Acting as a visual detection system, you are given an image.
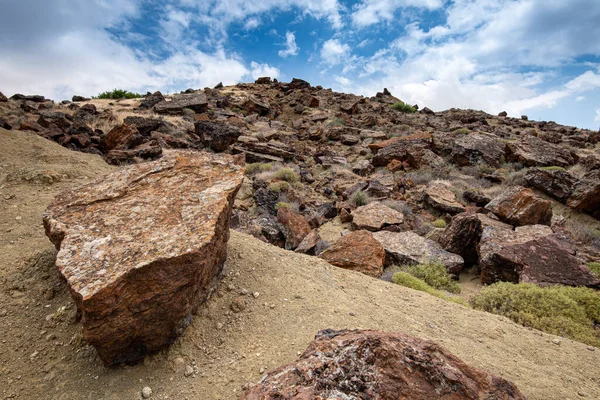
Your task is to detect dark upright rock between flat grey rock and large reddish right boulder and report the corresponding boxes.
[439,213,483,265]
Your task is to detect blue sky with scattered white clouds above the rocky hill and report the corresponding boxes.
[0,0,600,129]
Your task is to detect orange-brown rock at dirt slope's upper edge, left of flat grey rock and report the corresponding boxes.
[319,231,385,278]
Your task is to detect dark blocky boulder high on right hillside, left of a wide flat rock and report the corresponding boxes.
[450,133,505,168]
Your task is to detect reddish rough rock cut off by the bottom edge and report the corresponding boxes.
[241,330,525,400]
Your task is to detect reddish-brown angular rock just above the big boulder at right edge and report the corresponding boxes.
[485,186,552,226]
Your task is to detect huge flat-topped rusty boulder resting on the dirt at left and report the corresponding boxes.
[43,151,244,365]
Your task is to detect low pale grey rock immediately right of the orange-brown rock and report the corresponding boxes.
[373,231,464,274]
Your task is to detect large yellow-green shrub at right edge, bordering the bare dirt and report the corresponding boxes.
[471,282,600,347]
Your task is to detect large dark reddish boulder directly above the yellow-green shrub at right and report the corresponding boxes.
[480,225,600,287]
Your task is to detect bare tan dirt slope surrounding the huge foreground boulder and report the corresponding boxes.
[0,130,600,399]
